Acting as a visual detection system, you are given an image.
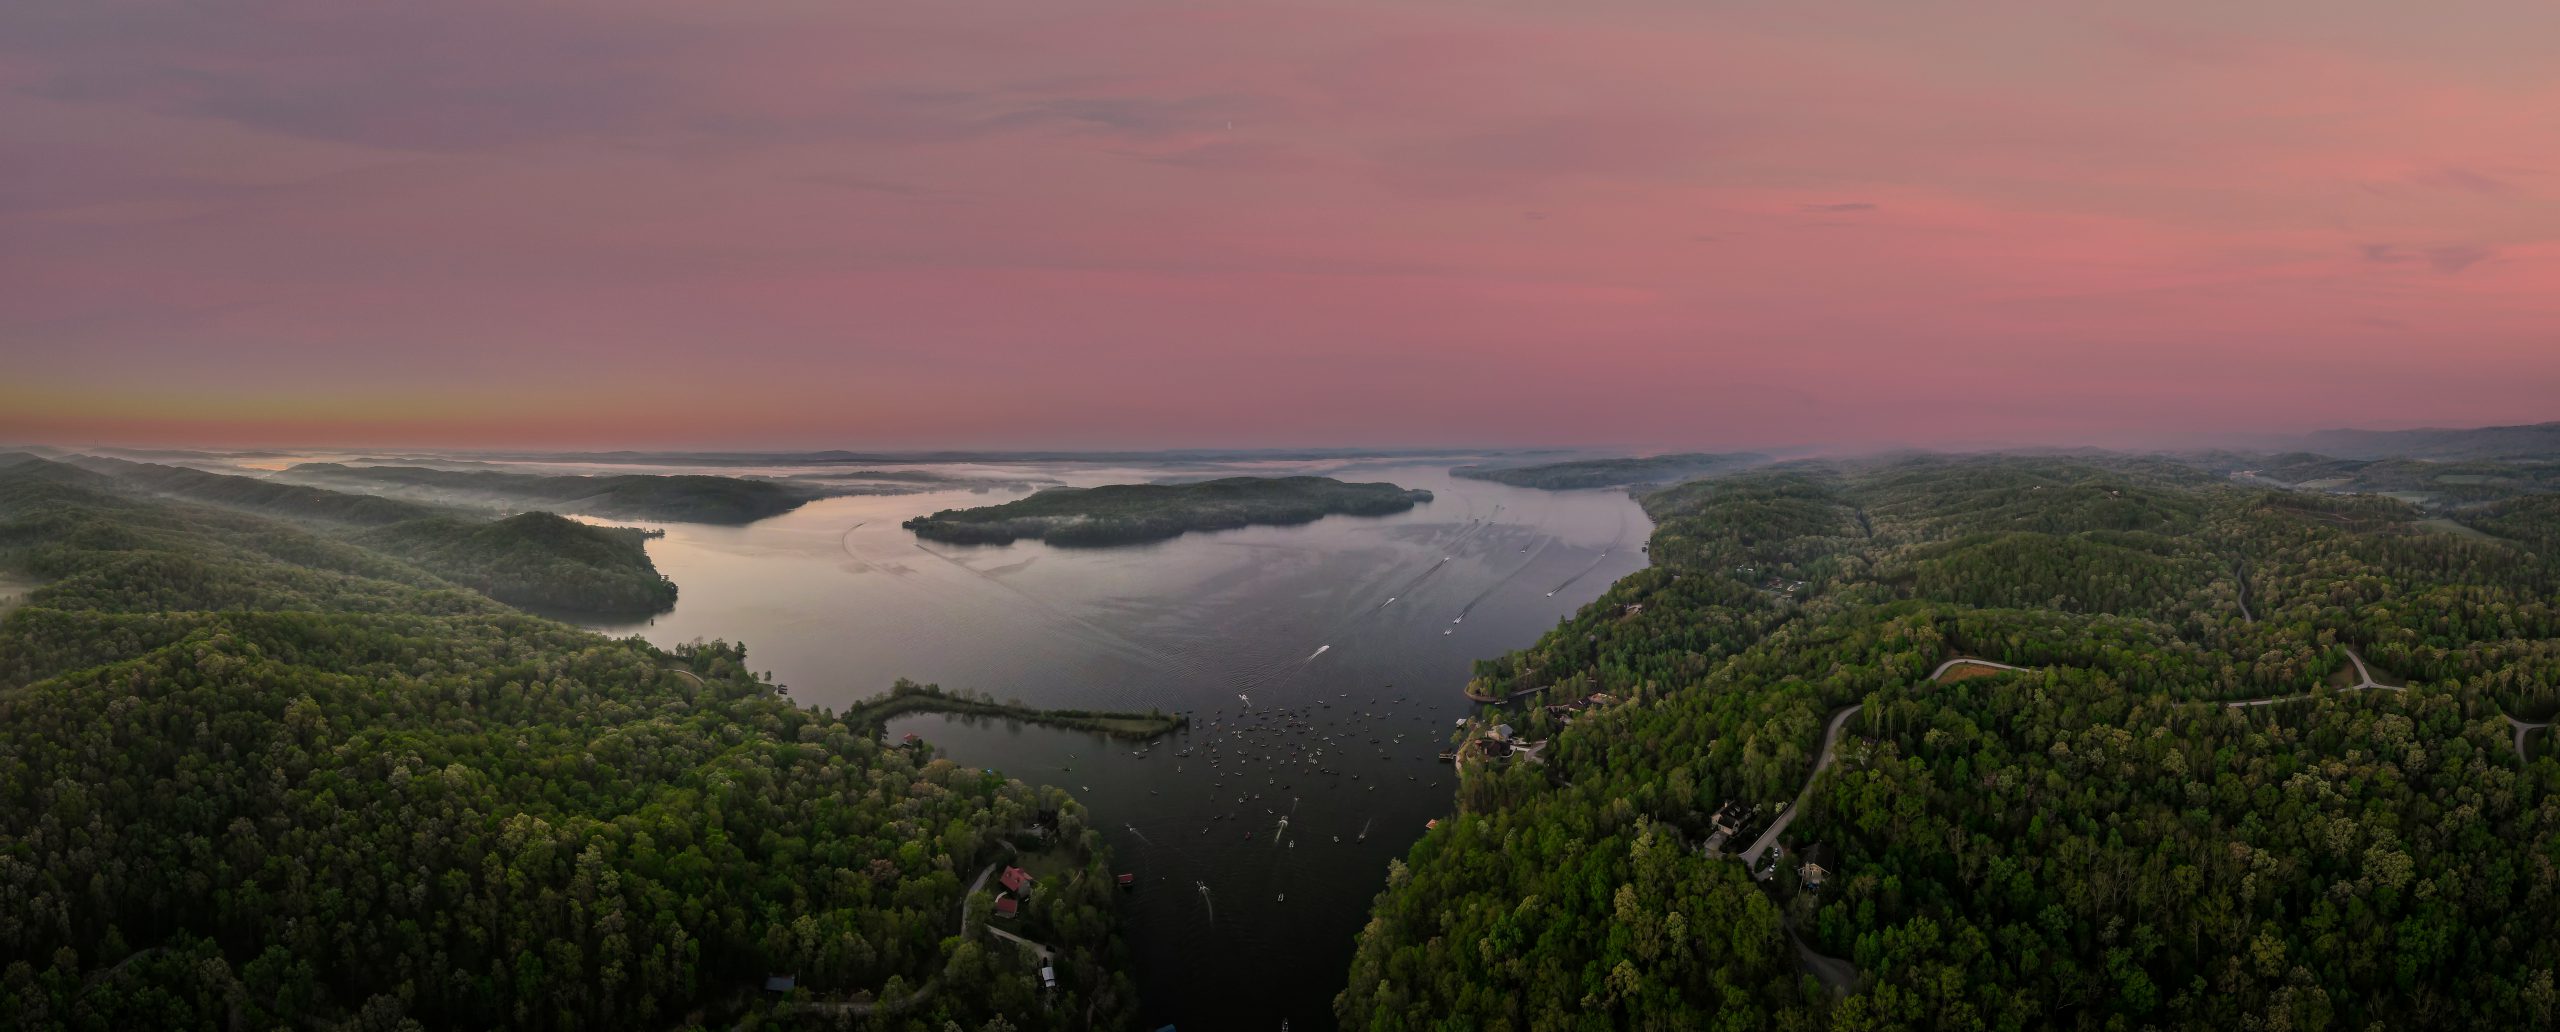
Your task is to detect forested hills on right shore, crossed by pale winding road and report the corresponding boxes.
[1336,458,2560,1032]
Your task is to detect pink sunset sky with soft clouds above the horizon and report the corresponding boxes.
[0,0,2560,448]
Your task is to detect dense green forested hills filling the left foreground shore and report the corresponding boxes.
[0,456,1134,1032]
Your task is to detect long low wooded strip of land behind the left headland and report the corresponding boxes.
[282,464,847,525]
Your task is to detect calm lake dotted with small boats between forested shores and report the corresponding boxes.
[583,464,1651,1029]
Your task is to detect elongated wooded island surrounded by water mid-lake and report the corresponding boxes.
[906,476,1431,545]
